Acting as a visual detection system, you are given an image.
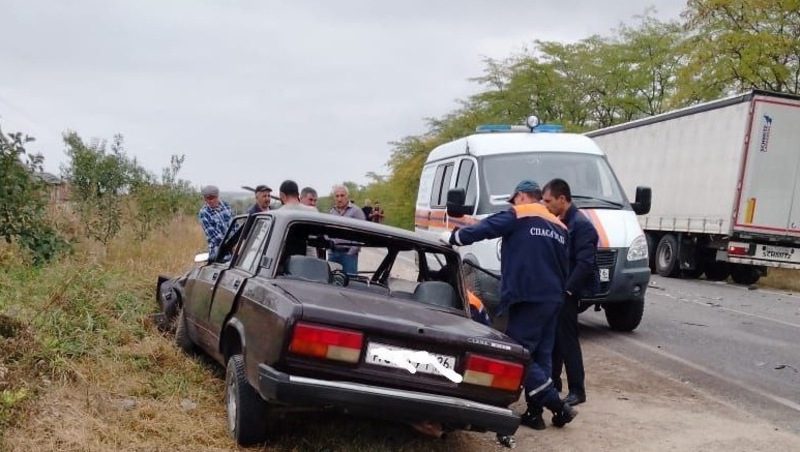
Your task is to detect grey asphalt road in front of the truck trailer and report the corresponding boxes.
[580,275,800,433]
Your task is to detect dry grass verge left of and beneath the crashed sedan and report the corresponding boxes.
[0,218,493,451]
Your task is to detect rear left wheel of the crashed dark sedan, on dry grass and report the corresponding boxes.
[225,354,267,446]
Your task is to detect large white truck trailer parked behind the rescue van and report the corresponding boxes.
[587,91,800,284]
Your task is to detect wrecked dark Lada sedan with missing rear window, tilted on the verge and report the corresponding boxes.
[157,209,529,444]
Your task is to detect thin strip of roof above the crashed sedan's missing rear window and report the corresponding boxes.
[255,207,452,250]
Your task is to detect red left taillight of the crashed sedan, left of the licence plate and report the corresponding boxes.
[289,322,364,363]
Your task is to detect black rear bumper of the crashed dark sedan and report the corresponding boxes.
[258,364,520,435]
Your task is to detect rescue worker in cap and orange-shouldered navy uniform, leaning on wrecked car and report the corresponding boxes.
[448,180,577,429]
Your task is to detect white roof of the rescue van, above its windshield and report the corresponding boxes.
[427,132,604,162]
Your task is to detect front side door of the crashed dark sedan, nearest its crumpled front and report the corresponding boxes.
[183,216,247,346]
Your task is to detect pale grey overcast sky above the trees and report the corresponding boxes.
[0,0,685,194]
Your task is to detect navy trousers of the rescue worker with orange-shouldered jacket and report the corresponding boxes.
[506,302,561,412]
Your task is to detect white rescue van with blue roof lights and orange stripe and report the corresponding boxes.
[415,117,650,331]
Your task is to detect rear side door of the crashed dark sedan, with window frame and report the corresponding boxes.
[208,216,272,343]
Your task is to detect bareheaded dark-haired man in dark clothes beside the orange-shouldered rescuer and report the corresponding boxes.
[543,179,598,405]
